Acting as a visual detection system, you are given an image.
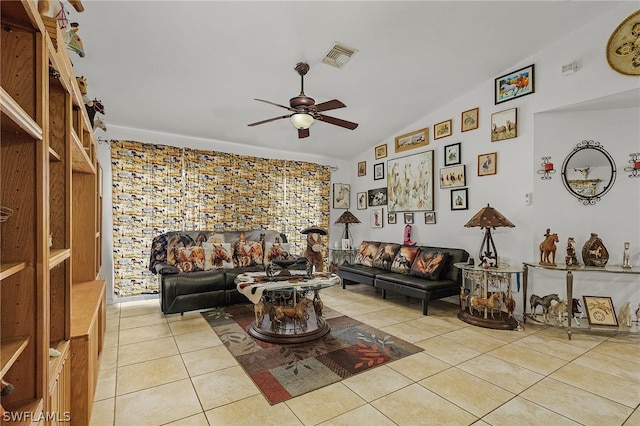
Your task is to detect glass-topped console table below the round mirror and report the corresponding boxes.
[522,262,640,340]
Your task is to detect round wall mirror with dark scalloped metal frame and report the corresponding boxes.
[562,141,616,205]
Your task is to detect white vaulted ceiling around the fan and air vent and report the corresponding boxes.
[68,0,616,159]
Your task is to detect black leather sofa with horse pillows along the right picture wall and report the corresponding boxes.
[338,241,469,315]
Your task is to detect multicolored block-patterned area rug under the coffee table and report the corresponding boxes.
[202,305,423,405]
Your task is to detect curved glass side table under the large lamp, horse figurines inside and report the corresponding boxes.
[454,262,522,330]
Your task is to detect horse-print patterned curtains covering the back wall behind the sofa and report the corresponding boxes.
[111,140,331,297]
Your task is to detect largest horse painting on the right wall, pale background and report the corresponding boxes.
[387,150,434,213]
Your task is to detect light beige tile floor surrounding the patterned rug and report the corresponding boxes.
[91,285,640,426]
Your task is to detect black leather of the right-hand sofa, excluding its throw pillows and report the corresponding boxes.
[338,243,469,315]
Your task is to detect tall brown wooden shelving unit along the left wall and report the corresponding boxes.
[0,0,105,424]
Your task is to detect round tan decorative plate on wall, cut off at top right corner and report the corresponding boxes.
[607,10,640,76]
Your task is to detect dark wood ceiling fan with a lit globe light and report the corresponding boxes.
[249,62,358,139]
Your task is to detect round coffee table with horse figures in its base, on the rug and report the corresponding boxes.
[235,271,340,343]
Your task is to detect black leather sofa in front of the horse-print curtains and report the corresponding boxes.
[149,229,306,314]
